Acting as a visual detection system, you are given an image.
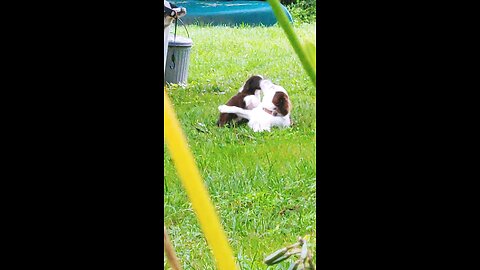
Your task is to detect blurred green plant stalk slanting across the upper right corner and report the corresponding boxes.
[267,0,317,86]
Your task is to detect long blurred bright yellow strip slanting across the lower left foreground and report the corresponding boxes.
[163,89,237,270]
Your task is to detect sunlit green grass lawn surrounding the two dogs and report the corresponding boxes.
[164,24,316,270]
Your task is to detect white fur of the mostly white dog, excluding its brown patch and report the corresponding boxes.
[218,80,291,132]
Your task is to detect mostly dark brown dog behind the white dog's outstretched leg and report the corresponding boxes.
[217,75,263,127]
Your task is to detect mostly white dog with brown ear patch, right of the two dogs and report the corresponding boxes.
[218,79,292,132]
